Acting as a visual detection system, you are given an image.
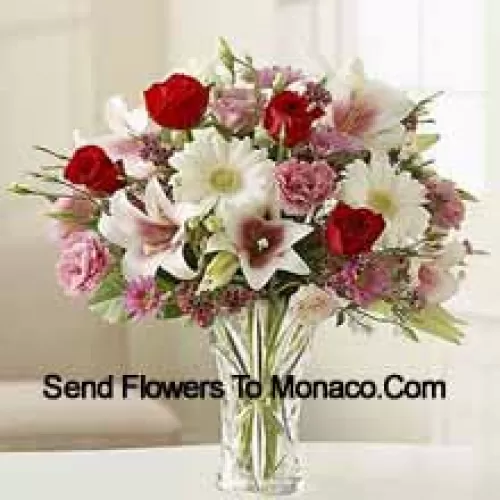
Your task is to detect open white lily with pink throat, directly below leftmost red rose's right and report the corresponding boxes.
[99,178,200,280]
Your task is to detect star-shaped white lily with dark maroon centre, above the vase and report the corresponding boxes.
[207,205,313,290]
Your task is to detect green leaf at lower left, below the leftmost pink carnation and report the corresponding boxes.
[89,269,128,323]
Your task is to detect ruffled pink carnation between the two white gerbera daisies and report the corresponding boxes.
[275,159,336,215]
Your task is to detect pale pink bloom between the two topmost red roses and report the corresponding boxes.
[212,88,260,134]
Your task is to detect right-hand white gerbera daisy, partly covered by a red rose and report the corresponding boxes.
[339,154,429,247]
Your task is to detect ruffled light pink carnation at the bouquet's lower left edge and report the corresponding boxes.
[56,231,111,295]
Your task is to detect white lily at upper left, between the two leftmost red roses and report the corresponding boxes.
[73,96,154,179]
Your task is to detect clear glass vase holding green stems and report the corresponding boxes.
[211,298,312,495]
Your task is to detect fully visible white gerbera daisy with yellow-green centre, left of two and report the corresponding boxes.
[170,130,274,215]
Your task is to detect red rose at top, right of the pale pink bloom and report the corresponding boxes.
[264,90,324,147]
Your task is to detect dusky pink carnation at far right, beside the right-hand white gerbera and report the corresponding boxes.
[426,177,465,229]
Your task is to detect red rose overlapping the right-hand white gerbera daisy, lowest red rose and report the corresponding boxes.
[326,202,385,255]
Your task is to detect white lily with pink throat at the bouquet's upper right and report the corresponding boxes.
[330,60,414,151]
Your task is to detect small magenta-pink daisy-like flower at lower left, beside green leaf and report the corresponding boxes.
[124,276,165,320]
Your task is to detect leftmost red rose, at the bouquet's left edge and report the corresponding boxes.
[64,146,125,194]
